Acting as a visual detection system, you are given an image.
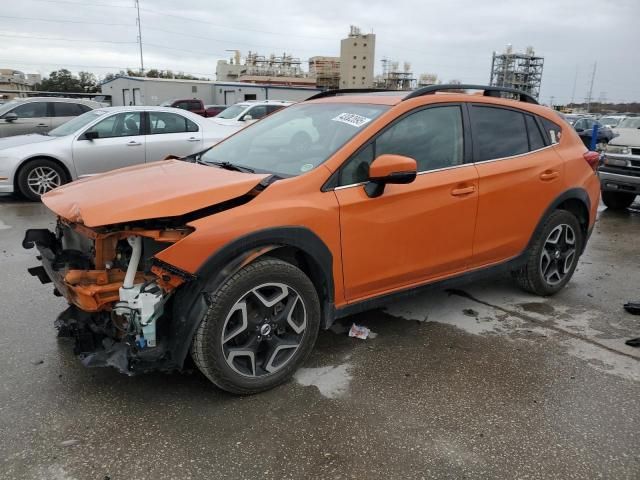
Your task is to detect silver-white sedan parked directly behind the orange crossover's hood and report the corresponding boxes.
[0,107,228,200]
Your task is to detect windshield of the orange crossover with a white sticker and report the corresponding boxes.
[200,103,389,177]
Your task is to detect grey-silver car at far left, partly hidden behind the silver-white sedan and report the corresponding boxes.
[0,97,102,137]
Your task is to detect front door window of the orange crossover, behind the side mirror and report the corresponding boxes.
[338,105,464,185]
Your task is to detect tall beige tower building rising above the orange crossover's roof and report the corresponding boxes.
[340,25,376,88]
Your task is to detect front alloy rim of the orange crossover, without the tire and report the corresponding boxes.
[221,283,307,377]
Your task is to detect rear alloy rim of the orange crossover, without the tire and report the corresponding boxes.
[540,223,576,286]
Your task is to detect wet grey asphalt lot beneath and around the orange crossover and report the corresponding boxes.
[0,193,640,480]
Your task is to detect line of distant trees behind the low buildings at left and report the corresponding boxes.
[34,68,209,93]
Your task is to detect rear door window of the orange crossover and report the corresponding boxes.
[471,105,529,162]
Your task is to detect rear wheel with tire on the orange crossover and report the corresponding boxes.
[513,210,584,296]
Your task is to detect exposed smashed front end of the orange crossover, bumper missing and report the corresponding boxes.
[23,219,191,375]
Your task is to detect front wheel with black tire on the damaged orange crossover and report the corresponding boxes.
[191,258,320,395]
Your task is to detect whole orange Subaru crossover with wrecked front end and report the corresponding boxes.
[24,85,600,393]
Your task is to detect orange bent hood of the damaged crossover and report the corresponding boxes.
[42,160,268,227]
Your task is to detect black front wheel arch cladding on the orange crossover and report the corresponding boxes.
[169,226,334,367]
